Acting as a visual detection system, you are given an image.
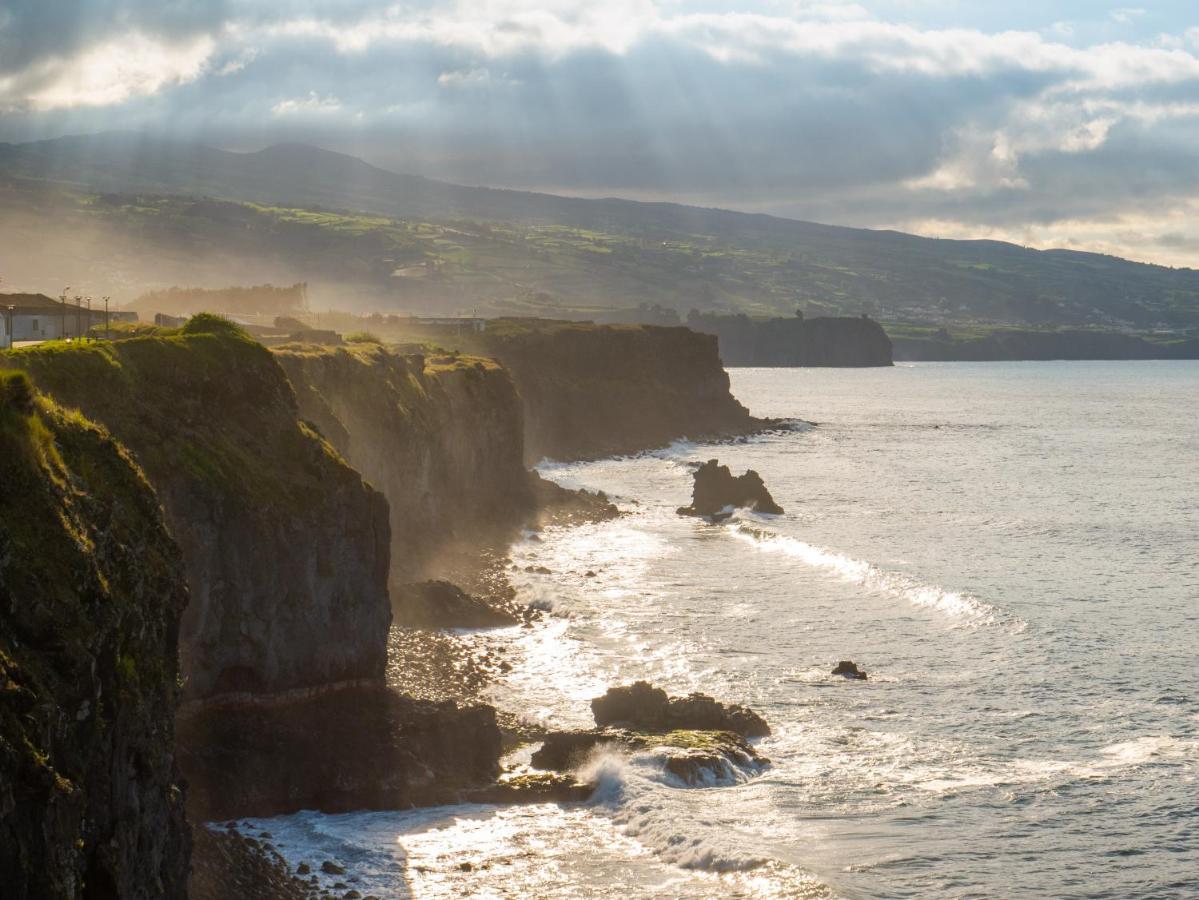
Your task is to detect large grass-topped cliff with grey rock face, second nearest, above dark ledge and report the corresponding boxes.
[4,316,391,700]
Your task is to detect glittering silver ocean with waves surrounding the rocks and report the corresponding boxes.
[254,362,1199,899]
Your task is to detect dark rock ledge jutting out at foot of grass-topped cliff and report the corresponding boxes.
[177,685,500,821]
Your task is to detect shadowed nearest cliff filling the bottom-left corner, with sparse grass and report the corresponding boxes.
[0,373,189,900]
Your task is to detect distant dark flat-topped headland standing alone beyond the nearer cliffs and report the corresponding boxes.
[687,312,892,368]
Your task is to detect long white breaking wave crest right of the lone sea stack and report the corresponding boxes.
[725,521,1026,632]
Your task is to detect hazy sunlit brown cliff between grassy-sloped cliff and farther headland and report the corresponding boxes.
[276,344,534,584]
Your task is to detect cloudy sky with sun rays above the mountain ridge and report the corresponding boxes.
[0,0,1199,267]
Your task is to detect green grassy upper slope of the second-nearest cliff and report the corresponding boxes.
[2,314,357,509]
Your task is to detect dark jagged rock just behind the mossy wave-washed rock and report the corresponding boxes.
[591,681,770,737]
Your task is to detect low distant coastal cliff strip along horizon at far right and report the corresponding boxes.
[894,331,1199,362]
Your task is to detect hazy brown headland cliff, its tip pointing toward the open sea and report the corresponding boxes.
[478,319,765,463]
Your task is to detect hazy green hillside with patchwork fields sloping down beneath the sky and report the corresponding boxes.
[0,135,1199,330]
